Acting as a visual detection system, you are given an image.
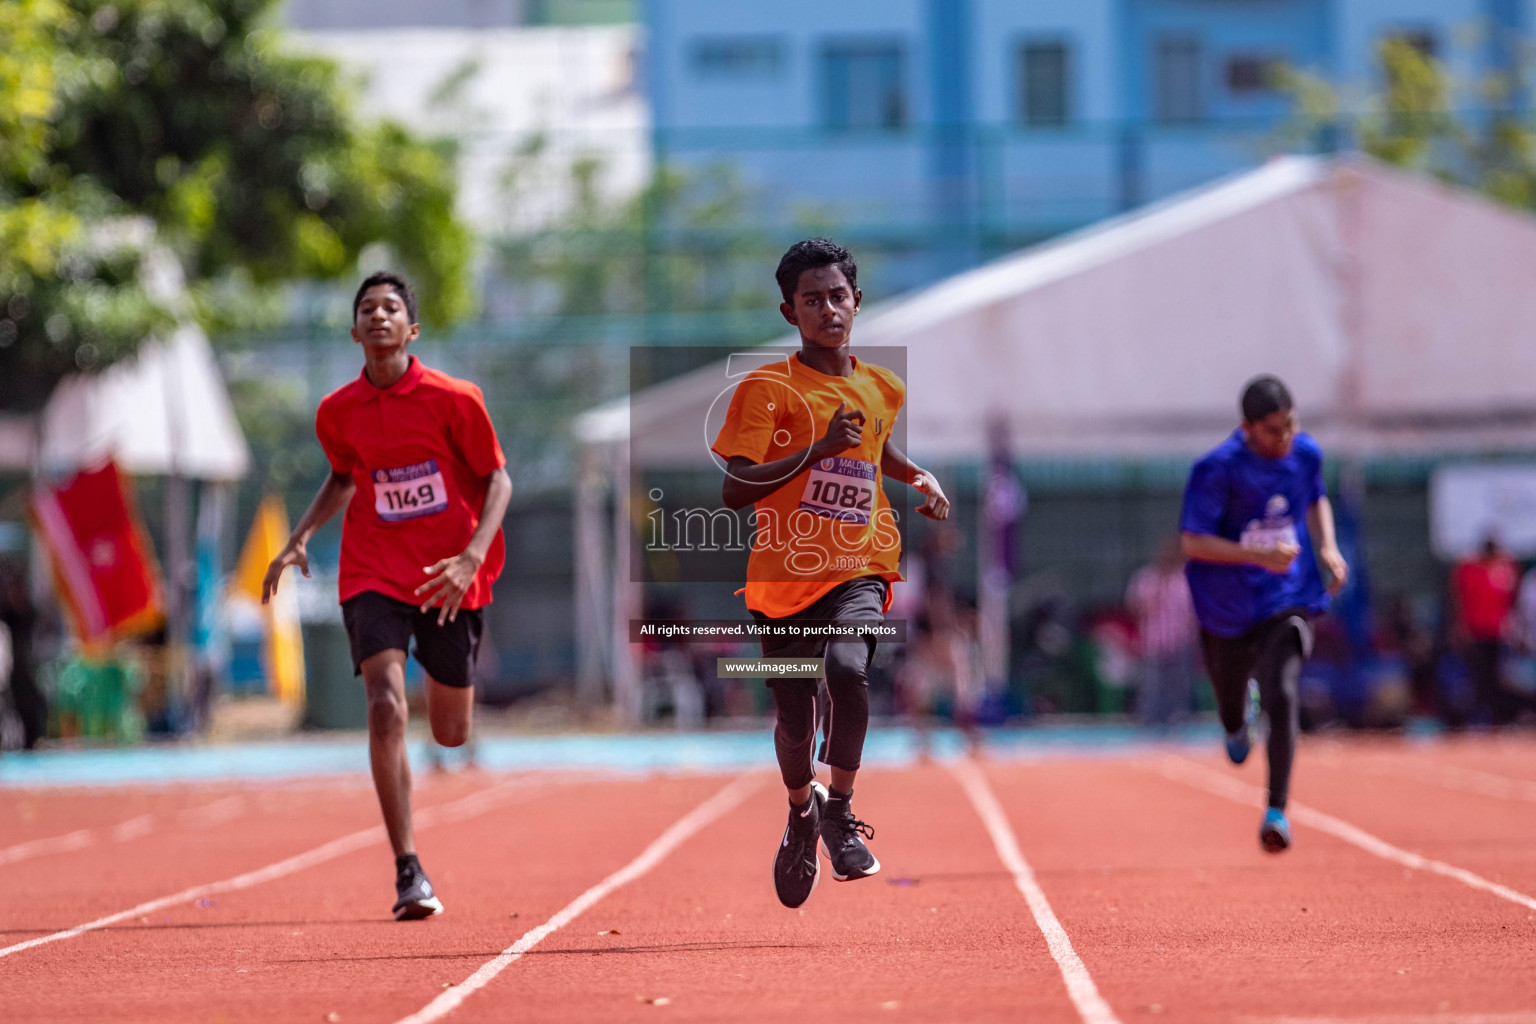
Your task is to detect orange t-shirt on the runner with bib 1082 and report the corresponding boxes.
[711,355,906,619]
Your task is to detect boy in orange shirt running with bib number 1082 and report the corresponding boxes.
[711,238,949,907]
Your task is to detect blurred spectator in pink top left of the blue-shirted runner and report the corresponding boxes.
[1126,537,1198,726]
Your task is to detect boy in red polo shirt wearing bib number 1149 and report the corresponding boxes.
[261,273,511,921]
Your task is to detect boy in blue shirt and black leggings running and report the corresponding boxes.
[1180,376,1349,854]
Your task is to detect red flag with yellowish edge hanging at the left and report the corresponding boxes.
[32,462,161,645]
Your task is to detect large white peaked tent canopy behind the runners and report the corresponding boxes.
[578,157,1536,465]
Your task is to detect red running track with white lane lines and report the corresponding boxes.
[0,737,1536,1024]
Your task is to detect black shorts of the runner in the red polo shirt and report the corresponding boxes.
[341,590,482,688]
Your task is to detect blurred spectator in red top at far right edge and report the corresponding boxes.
[1450,537,1519,725]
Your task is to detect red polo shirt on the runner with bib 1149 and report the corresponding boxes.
[315,356,507,608]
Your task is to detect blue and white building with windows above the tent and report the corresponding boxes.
[642,0,1536,284]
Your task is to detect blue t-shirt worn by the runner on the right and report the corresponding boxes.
[1180,430,1329,637]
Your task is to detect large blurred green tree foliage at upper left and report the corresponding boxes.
[0,0,473,407]
